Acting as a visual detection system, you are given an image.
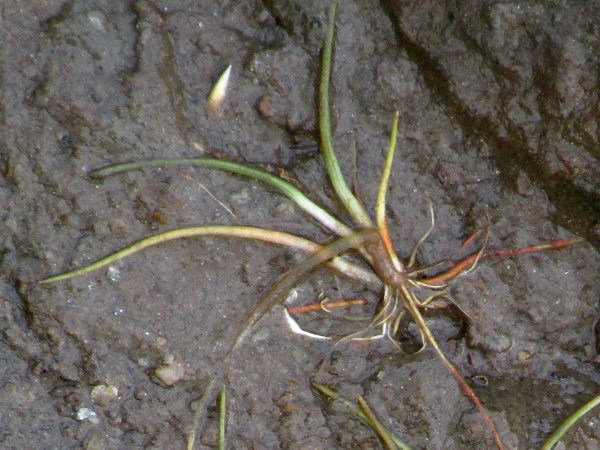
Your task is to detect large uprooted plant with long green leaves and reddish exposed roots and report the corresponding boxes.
[42,3,577,448]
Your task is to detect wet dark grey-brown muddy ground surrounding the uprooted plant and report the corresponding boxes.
[0,0,600,449]
